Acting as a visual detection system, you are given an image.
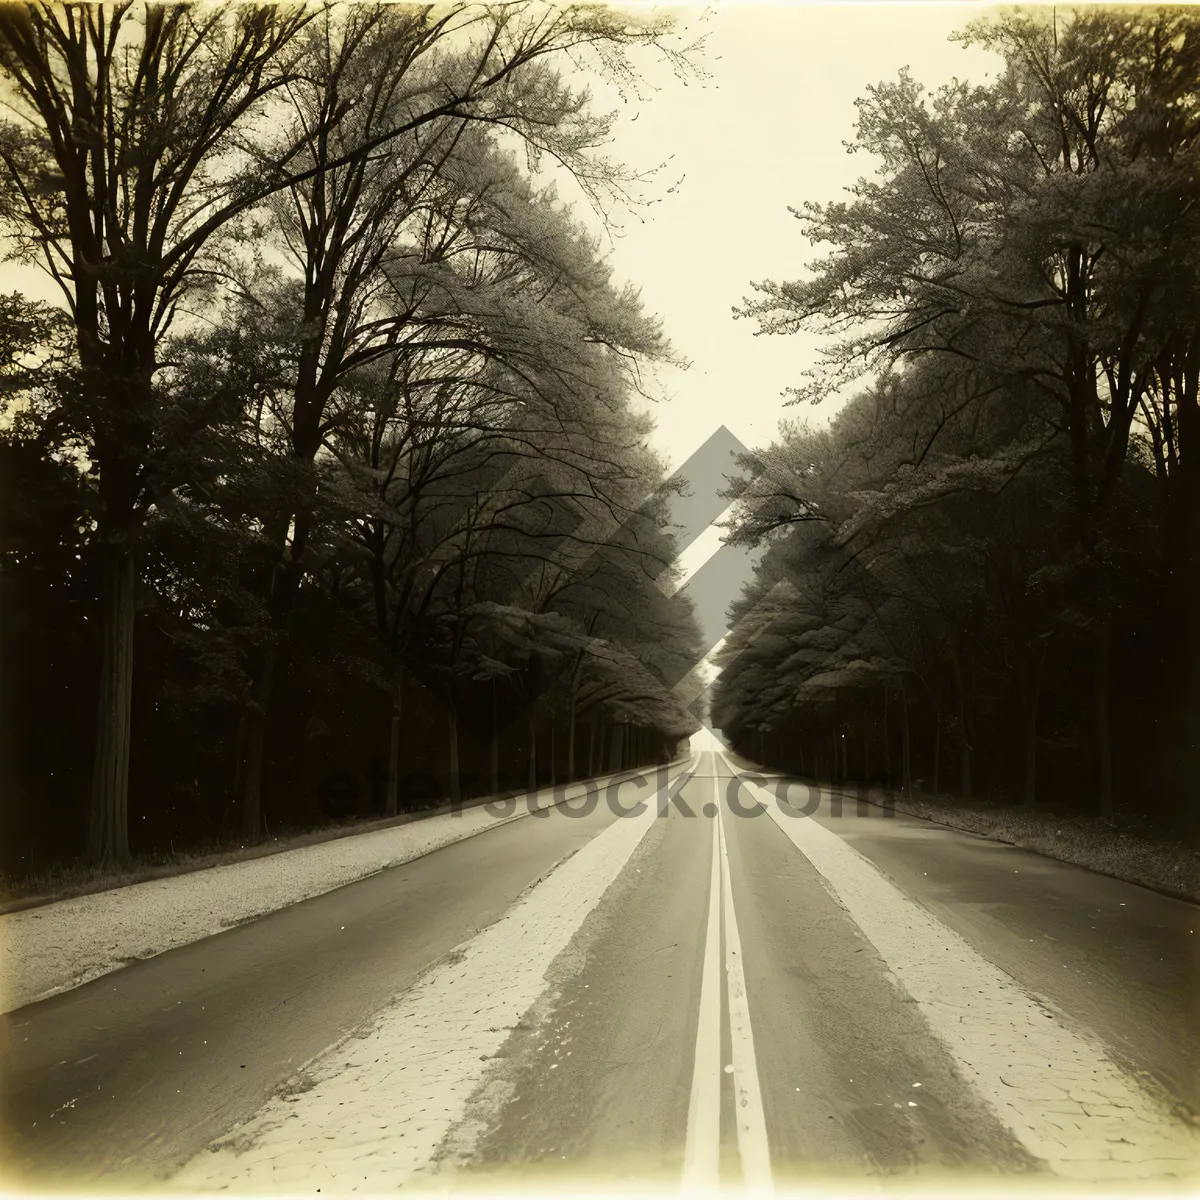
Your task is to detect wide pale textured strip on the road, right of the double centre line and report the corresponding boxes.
[743,763,1200,1181]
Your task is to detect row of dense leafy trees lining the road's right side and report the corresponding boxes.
[714,7,1200,828]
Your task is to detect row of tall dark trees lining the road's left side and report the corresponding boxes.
[0,2,700,870]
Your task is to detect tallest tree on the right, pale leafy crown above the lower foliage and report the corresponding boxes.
[740,10,1200,825]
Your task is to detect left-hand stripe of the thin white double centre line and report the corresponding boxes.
[683,753,721,1194]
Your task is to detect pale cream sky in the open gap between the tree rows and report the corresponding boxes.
[577,0,998,467]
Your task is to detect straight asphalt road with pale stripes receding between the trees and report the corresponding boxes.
[0,739,1200,1194]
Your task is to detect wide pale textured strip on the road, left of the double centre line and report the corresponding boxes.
[173,768,658,1194]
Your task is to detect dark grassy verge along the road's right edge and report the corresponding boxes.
[873,792,1200,904]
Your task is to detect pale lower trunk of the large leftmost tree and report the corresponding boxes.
[88,533,138,864]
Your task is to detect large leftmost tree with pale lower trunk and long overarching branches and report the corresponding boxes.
[0,4,696,859]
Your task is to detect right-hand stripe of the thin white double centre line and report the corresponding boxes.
[713,751,774,1195]
